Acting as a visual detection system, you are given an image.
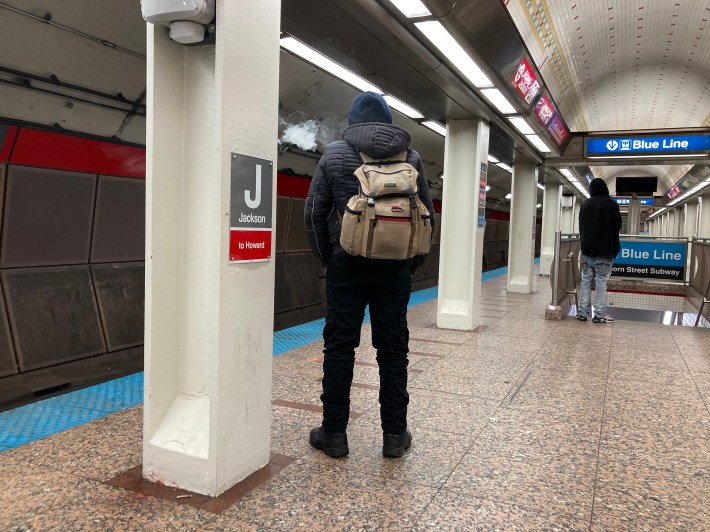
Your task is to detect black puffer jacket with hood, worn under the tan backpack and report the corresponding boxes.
[304,122,436,264]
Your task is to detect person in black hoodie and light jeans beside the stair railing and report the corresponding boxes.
[577,178,621,323]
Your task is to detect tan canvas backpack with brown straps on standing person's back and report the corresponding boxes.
[340,151,431,259]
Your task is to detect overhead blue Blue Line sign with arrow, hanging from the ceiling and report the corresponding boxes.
[585,135,710,155]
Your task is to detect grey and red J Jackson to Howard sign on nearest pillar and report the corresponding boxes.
[229,153,274,263]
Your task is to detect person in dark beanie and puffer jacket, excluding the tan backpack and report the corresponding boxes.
[305,92,434,457]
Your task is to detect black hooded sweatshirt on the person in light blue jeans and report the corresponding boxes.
[579,178,621,259]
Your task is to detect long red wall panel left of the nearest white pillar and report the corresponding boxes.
[10,127,145,179]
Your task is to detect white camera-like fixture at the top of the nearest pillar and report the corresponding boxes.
[141,0,215,45]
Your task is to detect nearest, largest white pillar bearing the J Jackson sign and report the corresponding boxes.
[143,0,281,496]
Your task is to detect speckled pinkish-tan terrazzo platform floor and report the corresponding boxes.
[0,278,710,531]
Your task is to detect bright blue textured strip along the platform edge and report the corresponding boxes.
[0,259,516,453]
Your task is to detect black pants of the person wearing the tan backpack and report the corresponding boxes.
[321,253,412,434]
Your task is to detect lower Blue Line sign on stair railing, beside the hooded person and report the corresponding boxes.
[612,241,686,281]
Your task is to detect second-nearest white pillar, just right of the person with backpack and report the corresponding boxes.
[436,120,489,330]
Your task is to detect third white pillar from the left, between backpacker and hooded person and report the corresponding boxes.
[507,164,538,294]
